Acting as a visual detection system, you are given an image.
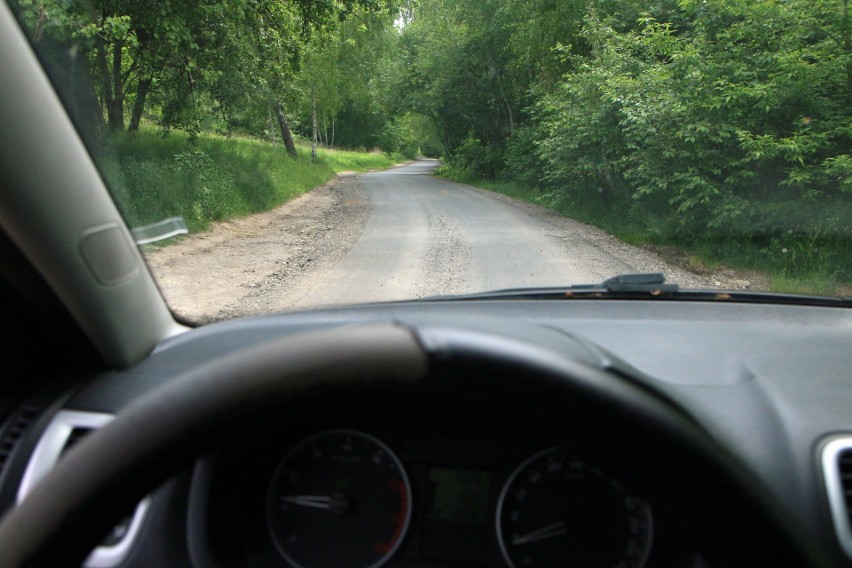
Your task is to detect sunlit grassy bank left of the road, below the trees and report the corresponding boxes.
[99,129,402,232]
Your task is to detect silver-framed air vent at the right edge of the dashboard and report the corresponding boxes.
[822,437,852,558]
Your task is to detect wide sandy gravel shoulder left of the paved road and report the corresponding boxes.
[146,174,368,323]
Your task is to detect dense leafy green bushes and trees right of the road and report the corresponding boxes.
[414,0,852,288]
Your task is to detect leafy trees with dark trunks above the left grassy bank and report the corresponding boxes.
[12,0,396,141]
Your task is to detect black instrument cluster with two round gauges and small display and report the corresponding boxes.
[190,412,705,568]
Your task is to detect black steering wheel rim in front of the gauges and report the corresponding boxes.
[0,324,831,568]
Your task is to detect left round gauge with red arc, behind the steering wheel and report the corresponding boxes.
[267,430,411,568]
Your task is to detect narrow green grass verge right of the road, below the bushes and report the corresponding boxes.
[437,168,852,296]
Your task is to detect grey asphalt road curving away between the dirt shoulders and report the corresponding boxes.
[282,160,633,305]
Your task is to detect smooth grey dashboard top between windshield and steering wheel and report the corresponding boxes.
[68,301,852,522]
